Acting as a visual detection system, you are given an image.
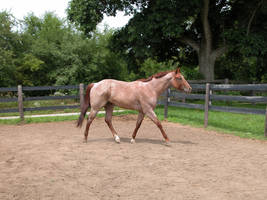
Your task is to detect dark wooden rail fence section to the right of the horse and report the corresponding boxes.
[158,83,267,137]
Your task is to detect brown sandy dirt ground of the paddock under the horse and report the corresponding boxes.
[0,115,267,200]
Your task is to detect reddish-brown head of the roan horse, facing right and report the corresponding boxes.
[171,68,192,93]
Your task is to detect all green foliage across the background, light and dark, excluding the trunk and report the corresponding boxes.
[0,0,267,87]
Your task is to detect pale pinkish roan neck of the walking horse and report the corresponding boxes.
[149,73,172,96]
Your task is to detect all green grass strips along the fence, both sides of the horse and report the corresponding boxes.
[0,106,267,140]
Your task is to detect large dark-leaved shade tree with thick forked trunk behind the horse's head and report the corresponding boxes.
[68,0,266,80]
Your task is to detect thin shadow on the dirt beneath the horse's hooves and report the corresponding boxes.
[87,137,197,145]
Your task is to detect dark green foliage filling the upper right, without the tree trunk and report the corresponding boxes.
[68,0,267,81]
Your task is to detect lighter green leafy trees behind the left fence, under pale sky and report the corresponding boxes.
[0,12,128,87]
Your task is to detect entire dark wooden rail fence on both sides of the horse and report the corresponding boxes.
[0,83,267,137]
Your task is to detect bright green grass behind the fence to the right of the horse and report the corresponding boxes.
[156,106,267,140]
